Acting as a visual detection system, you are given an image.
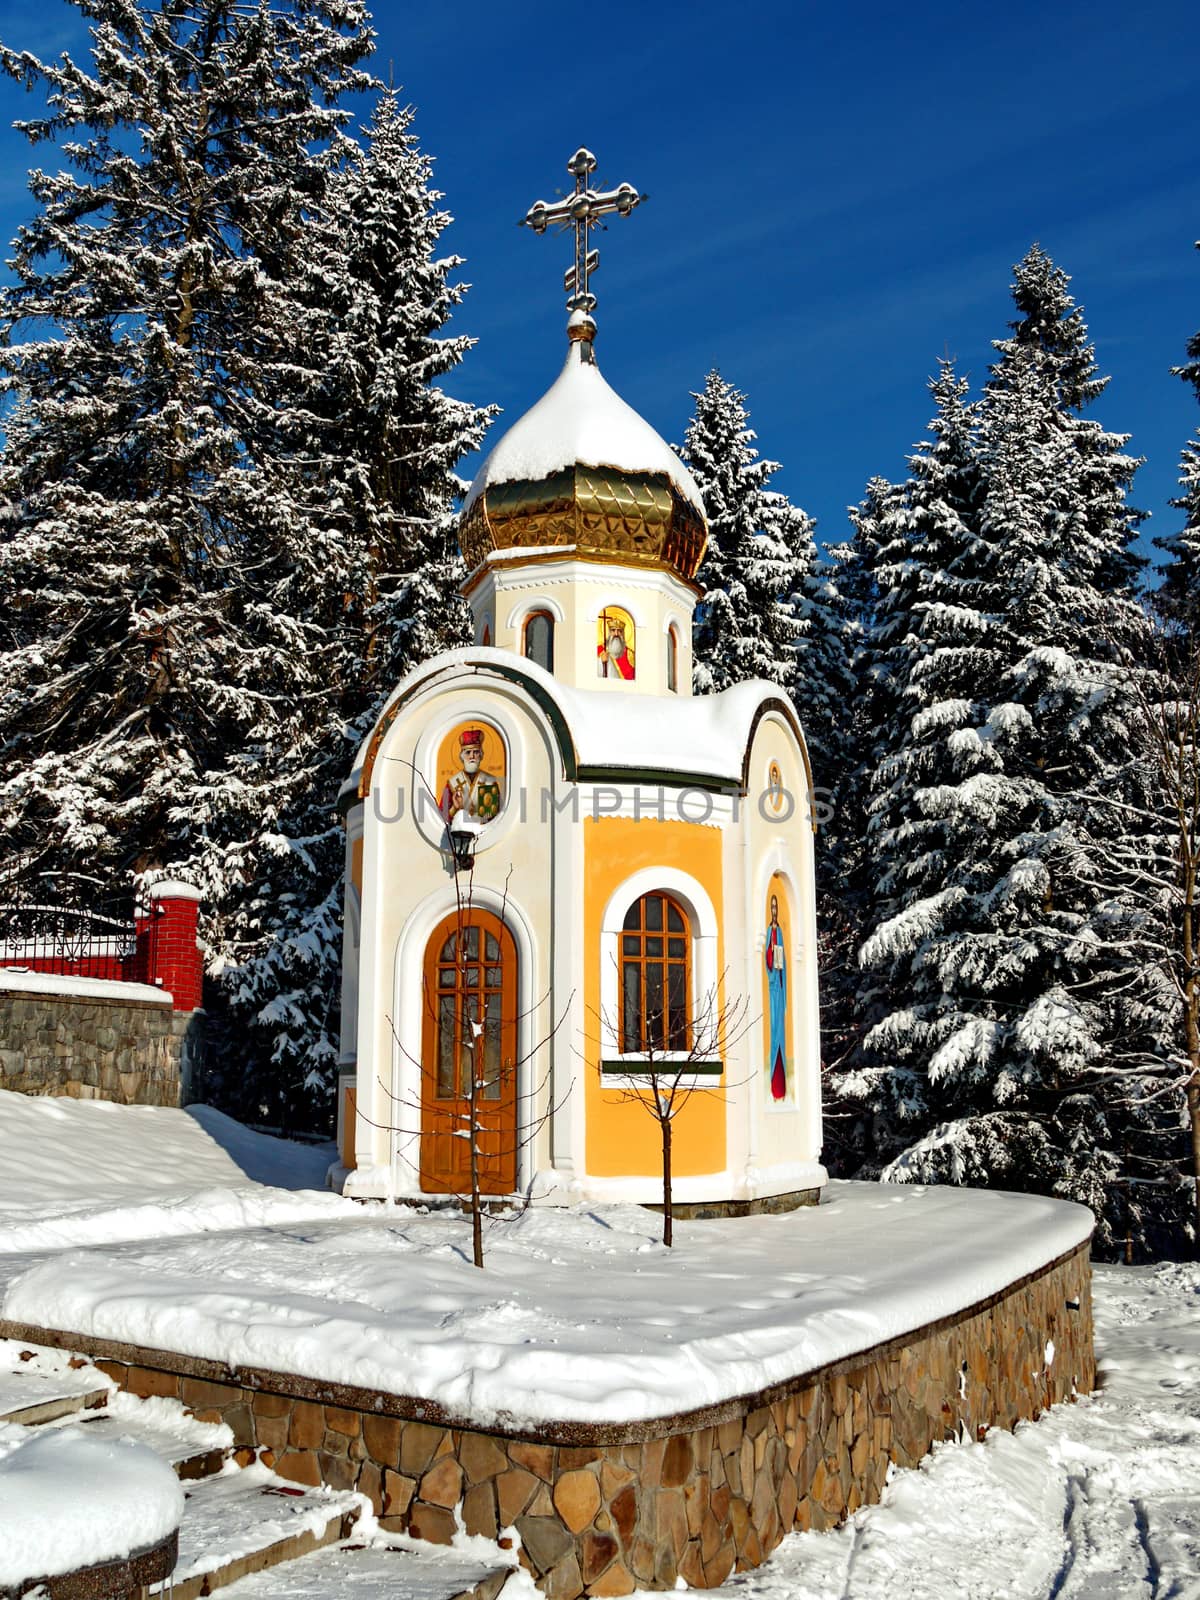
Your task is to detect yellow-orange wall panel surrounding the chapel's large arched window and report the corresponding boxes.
[582,816,726,1178]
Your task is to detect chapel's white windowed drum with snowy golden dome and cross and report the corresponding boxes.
[459,149,707,694]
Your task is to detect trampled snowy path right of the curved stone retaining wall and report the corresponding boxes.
[717,1266,1200,1600]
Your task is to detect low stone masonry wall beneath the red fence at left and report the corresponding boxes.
[0,987,203,1106]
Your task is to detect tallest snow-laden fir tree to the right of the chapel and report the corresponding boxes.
[846,246,1184,1238]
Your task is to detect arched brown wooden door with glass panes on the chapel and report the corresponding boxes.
[421,910,517,1195]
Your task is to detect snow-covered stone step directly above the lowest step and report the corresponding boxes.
[150,1462,362,1600]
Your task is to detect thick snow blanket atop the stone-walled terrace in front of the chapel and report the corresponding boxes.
[0,1184,1091,1426]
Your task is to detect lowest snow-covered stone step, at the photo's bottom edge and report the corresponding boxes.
[216,1544,512,1600]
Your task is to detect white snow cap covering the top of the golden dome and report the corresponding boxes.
[462,342,704,517]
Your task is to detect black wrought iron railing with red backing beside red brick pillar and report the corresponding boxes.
[0,872,158,982]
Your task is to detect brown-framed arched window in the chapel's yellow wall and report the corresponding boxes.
[621,894,691,1054]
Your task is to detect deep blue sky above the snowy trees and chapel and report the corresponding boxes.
[0,0,1200,563]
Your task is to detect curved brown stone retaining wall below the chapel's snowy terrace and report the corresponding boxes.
[0,1245,1094,1600]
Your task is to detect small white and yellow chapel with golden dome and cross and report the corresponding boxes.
[339,150,826,1214]
